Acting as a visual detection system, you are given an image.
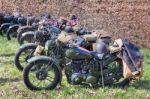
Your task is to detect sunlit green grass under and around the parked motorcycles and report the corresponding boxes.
[0,37,150,99]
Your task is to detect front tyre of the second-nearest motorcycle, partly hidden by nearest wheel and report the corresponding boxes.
[14,44,37,71]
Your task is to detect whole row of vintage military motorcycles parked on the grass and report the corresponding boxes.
[0,12,143,90]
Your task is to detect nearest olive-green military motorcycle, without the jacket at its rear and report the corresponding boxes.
[23,31,123,90]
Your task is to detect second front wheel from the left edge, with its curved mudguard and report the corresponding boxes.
[6,24,19,40]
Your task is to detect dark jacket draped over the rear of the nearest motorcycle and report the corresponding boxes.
[118,40,144,75]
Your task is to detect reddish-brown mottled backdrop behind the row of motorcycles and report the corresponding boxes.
[0,0,150,48]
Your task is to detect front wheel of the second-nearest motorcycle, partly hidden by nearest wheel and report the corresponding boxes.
[15,44,37,71]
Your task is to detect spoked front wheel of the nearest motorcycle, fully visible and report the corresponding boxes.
[23,60,61,90]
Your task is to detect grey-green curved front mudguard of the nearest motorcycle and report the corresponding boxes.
[28,56,62,83]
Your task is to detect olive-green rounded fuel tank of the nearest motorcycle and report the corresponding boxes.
[65,47,92,60]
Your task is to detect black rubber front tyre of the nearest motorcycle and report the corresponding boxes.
[23,60,62,91]
